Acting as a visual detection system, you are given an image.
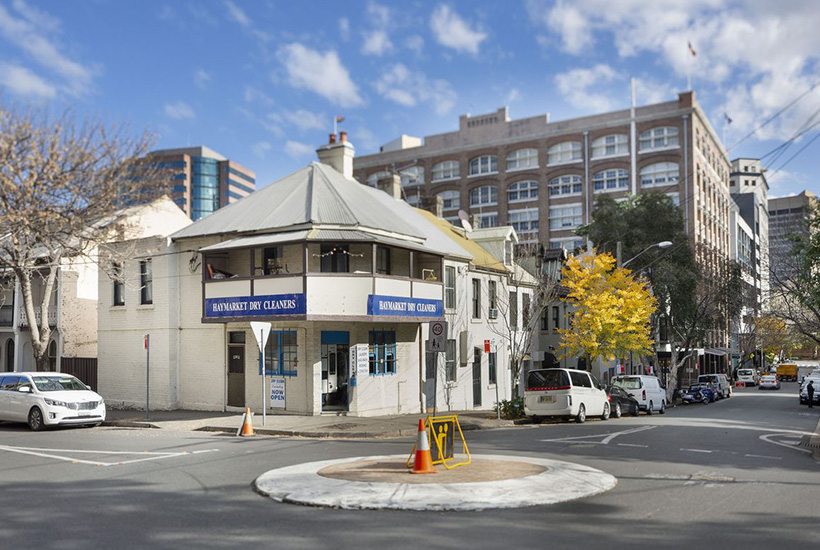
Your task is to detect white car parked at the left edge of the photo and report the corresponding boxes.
[0,372,105,431]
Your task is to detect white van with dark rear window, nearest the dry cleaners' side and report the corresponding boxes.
[524,369,609,424]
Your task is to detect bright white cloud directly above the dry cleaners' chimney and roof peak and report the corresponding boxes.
[279,42,364,107]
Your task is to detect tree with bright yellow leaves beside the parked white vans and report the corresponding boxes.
[559,254,657,365]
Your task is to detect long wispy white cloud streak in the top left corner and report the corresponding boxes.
[0,2,93,96]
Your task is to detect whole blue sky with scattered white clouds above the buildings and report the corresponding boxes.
[0,0,820,196]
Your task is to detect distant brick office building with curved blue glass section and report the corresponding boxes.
[150,146,256,221]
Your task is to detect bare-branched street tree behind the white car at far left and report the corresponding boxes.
[0,105,168,370]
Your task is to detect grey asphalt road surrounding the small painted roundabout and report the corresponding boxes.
[0,384,820,550]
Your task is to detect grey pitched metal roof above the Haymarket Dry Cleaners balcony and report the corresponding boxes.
[171,162,425,240]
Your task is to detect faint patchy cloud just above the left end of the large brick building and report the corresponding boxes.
[374,63,457,115]
